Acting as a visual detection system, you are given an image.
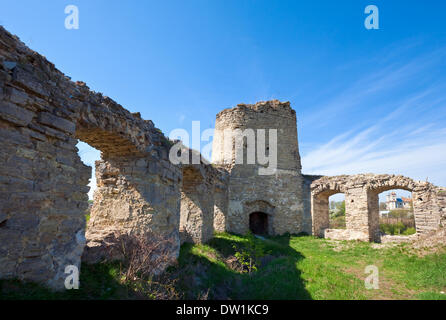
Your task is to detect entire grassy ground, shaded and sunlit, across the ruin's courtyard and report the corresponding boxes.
[0,233,446,300]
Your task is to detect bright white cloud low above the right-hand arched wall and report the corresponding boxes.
[302,119,446,185]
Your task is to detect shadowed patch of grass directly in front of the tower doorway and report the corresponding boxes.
[178,234,311,300]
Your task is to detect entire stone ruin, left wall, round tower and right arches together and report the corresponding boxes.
[0,27,446,289]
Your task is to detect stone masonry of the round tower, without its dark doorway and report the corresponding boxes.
[212,100,305,234]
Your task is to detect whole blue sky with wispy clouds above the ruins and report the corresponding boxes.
[0,0,446,200]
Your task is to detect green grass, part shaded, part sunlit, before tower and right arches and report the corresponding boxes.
[174,233,446,299]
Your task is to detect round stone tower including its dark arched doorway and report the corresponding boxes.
[212,100,308,235]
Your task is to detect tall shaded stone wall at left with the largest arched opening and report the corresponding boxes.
[0,27,179,289]
